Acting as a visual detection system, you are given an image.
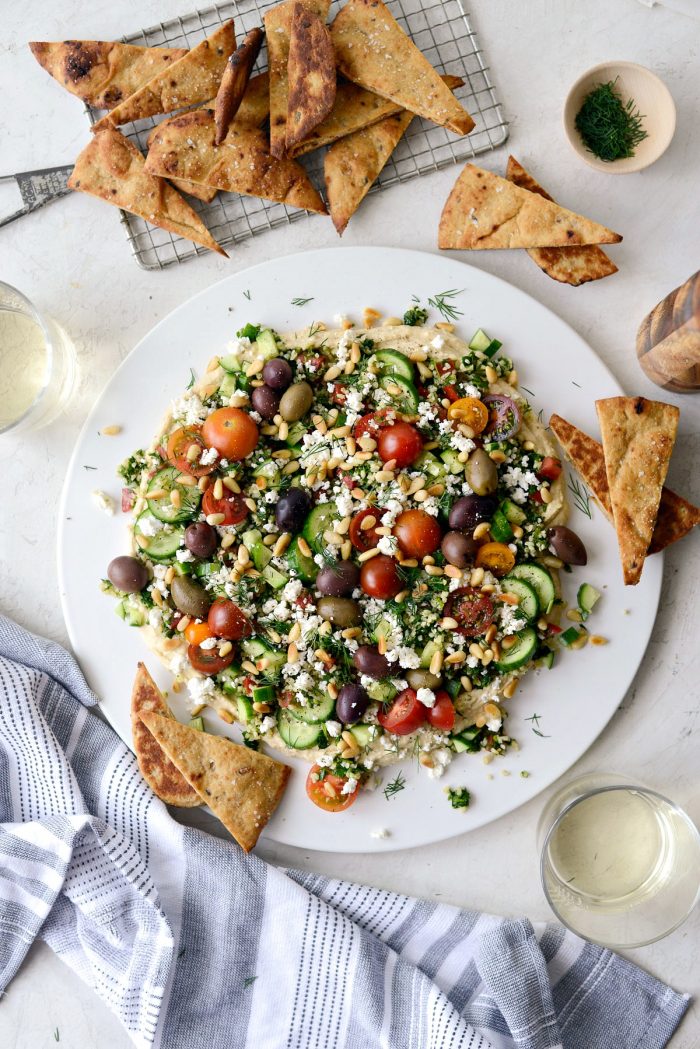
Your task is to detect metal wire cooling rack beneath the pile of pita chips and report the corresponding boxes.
[87,0,508,270]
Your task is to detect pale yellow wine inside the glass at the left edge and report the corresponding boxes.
[0,308,48,427]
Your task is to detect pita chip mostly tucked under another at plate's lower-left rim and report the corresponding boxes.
[131,663,201,809]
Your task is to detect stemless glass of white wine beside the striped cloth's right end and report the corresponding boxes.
[537,773,700,948]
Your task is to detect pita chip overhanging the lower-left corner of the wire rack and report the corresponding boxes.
[68,128,228,258]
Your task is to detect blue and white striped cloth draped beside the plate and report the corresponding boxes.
[0,617,687,1049]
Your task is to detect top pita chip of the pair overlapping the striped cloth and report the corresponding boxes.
[143,713,291,852]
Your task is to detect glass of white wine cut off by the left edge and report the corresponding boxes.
[0,281,76,436]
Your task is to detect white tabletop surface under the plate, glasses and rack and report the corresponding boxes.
[0,0,700,1049]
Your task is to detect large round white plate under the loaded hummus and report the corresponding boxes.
[59,248,662,853]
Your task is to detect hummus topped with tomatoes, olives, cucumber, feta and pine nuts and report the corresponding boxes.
[103,308,597,811]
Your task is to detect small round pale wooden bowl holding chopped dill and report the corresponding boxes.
[564,62,676,175]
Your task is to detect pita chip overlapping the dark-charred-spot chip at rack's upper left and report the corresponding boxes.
[92,20,236,130]
